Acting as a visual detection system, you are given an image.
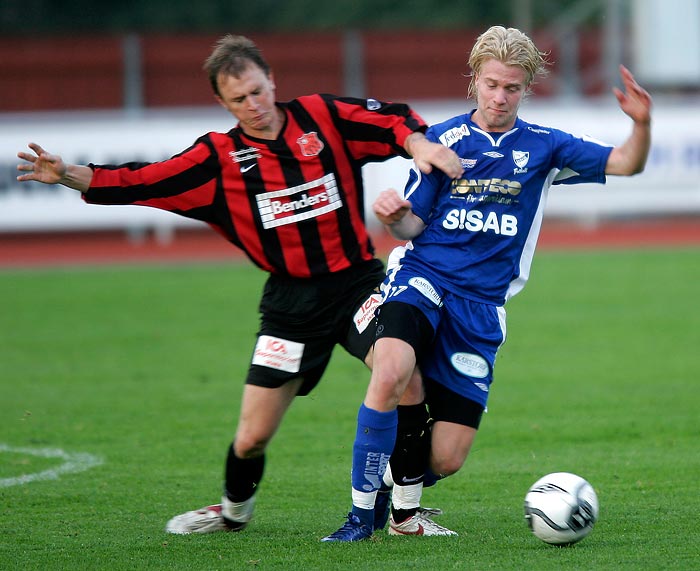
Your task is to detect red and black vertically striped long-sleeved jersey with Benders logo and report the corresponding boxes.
[83,94,426,278]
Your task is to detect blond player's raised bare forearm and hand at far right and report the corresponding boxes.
[605,66,651,176]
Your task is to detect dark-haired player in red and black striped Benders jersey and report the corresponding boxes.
[17,35,462,534]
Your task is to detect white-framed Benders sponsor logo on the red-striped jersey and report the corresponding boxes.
[255,173,343,230]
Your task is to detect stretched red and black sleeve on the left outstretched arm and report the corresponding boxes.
[83,135,220,219]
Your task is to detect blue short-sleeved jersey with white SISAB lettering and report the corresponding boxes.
[401,113,612,305]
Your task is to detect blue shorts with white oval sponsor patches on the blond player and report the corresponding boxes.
[379,267,506,408]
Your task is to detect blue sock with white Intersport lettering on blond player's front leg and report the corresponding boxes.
[352,403,398,529]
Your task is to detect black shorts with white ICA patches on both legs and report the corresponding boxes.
[246,259,384,395]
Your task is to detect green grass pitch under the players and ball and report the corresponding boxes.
[0,248,700,571]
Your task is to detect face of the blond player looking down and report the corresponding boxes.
[473,59,527,133]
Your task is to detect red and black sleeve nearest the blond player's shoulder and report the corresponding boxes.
[321,95,427,162]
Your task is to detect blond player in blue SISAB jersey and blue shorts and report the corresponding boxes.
[323,26,651,541]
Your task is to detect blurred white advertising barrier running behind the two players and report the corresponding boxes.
[0,99,700,235]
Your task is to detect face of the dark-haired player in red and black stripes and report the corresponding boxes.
[217,64,282,139]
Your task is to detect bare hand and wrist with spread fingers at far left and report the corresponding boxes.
[17,143,92,192]
